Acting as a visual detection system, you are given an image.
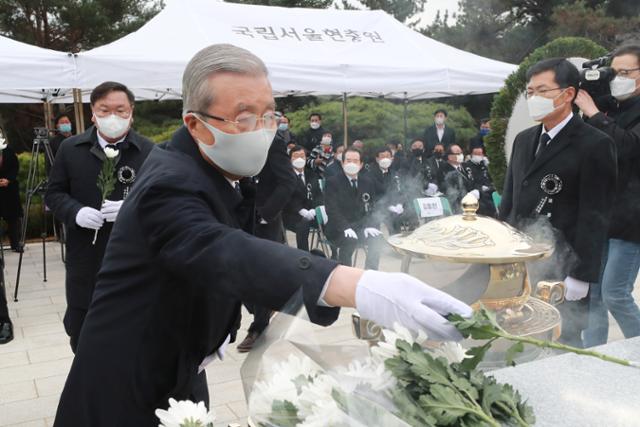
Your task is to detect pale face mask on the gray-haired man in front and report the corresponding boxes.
[194,115,276,176]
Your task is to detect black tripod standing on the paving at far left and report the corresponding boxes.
[13,128,53,302]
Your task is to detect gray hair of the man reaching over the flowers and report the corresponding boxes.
[182,44,268,115]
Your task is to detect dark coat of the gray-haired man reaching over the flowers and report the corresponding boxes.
[54,127,339,427]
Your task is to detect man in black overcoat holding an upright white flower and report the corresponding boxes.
[45,82,154,352]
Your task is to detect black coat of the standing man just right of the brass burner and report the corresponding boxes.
[499,115,617,283]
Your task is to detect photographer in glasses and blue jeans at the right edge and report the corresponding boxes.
[575,45,640,347]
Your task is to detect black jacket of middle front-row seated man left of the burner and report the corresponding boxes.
[325,173,380,240]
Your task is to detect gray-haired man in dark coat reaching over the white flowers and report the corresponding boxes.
[54,44,471,427]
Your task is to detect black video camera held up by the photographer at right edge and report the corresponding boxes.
[580,54,616,111]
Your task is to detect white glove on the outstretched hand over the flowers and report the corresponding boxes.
[356,270,473,341]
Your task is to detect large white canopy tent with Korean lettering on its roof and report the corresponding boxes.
[76,0,515,99]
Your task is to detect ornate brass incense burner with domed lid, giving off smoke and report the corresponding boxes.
[353,195,564,366]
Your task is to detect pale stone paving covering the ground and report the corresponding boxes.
[0,235,640,427]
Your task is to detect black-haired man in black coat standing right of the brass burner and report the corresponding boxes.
[499,58,616,346]
